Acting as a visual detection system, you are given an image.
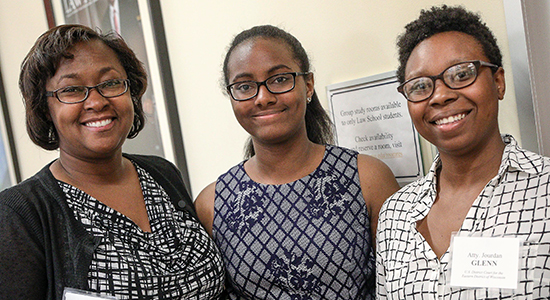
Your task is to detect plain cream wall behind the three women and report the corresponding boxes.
[0,0,521,196]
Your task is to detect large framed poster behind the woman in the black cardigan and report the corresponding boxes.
[44,0,189,191]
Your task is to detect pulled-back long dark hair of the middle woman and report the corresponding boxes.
[223,25,334,159]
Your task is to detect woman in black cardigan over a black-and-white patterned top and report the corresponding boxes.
[0,25,224,300]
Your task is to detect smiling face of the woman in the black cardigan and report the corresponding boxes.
[46,40,134,162]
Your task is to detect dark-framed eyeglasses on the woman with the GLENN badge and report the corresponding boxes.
[397,60,499,102]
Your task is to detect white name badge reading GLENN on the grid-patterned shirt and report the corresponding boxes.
[450,236,521,289]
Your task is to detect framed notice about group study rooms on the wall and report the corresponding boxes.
[327,71,424,185]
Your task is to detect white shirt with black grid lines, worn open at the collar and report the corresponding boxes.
[377,135,550,300]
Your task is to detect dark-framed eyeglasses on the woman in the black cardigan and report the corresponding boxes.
[46,79,130,104]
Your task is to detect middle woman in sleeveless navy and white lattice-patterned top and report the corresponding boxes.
[195,25,398,299]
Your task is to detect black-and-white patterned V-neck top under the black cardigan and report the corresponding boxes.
[63,164,224,299]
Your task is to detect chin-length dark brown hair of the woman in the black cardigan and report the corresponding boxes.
[19,24,147,150]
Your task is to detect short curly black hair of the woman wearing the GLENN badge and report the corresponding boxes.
[397,5,502,83]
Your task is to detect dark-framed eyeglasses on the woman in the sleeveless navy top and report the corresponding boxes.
[226,72,310,101]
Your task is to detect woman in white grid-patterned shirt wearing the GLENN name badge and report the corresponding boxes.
[377,5,550,299]
